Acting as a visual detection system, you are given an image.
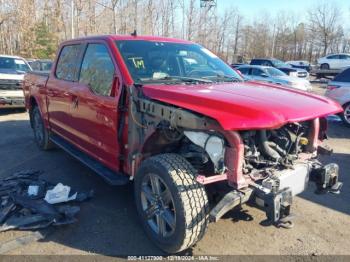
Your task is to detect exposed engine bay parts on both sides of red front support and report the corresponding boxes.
[181,122,311,180]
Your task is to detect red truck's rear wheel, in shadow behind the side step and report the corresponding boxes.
[30,106,53,151]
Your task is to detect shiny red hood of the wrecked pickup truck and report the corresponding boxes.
[142,81,342,130]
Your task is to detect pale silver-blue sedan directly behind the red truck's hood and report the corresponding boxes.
[237,65,312,91]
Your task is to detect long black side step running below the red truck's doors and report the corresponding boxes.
[50,134,129,186]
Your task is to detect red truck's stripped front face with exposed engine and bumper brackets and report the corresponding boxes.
[205,119,342,227]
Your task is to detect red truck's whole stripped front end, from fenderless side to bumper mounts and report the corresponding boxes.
[125,87,342,227]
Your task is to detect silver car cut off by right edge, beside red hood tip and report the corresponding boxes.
[326,68,350,127]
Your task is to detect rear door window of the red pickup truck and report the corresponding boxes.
[56,45,82,81]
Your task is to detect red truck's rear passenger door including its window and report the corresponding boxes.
[46,44,84,141]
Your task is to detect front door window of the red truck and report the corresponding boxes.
[79,44,115,96]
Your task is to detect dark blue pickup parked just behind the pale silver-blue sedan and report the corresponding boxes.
[250,58,309,78]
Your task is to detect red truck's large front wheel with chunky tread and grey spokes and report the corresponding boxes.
[134,154,209,253]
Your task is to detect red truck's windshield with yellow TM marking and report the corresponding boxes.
[116,40,243,83]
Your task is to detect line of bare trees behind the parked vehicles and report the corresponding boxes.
[0,0,350,62]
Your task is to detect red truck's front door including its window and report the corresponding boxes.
[72,41,121,170]
